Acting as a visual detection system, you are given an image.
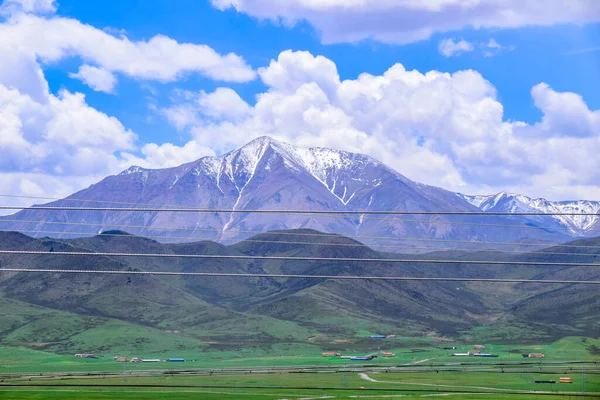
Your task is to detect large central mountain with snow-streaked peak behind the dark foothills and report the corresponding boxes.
[0,137,572,251]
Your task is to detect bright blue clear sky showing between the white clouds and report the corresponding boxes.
[47,0,600,143]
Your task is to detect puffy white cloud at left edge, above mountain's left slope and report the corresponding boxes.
[0,48,137,211]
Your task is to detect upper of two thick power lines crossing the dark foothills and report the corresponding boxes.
[0,250,600,267]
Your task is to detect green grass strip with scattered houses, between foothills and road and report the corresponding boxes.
[0,337,600,375]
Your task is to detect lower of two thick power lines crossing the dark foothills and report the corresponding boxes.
[0,268,600,285]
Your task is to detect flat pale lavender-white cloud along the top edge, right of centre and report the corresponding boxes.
[211,0,600,44]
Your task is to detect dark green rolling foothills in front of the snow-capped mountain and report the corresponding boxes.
[0,230,600,354]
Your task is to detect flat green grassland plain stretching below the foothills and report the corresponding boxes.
[0,337,600,399]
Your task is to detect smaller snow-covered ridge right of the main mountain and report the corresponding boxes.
[458,192,600,236]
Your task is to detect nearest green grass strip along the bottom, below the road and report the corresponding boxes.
[0,372,600,399]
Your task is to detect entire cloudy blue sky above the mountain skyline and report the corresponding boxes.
[0,0,600,203]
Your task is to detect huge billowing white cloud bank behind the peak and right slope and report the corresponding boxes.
[156,51,600,199]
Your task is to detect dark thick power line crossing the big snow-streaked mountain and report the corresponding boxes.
[0,205,600,217]
